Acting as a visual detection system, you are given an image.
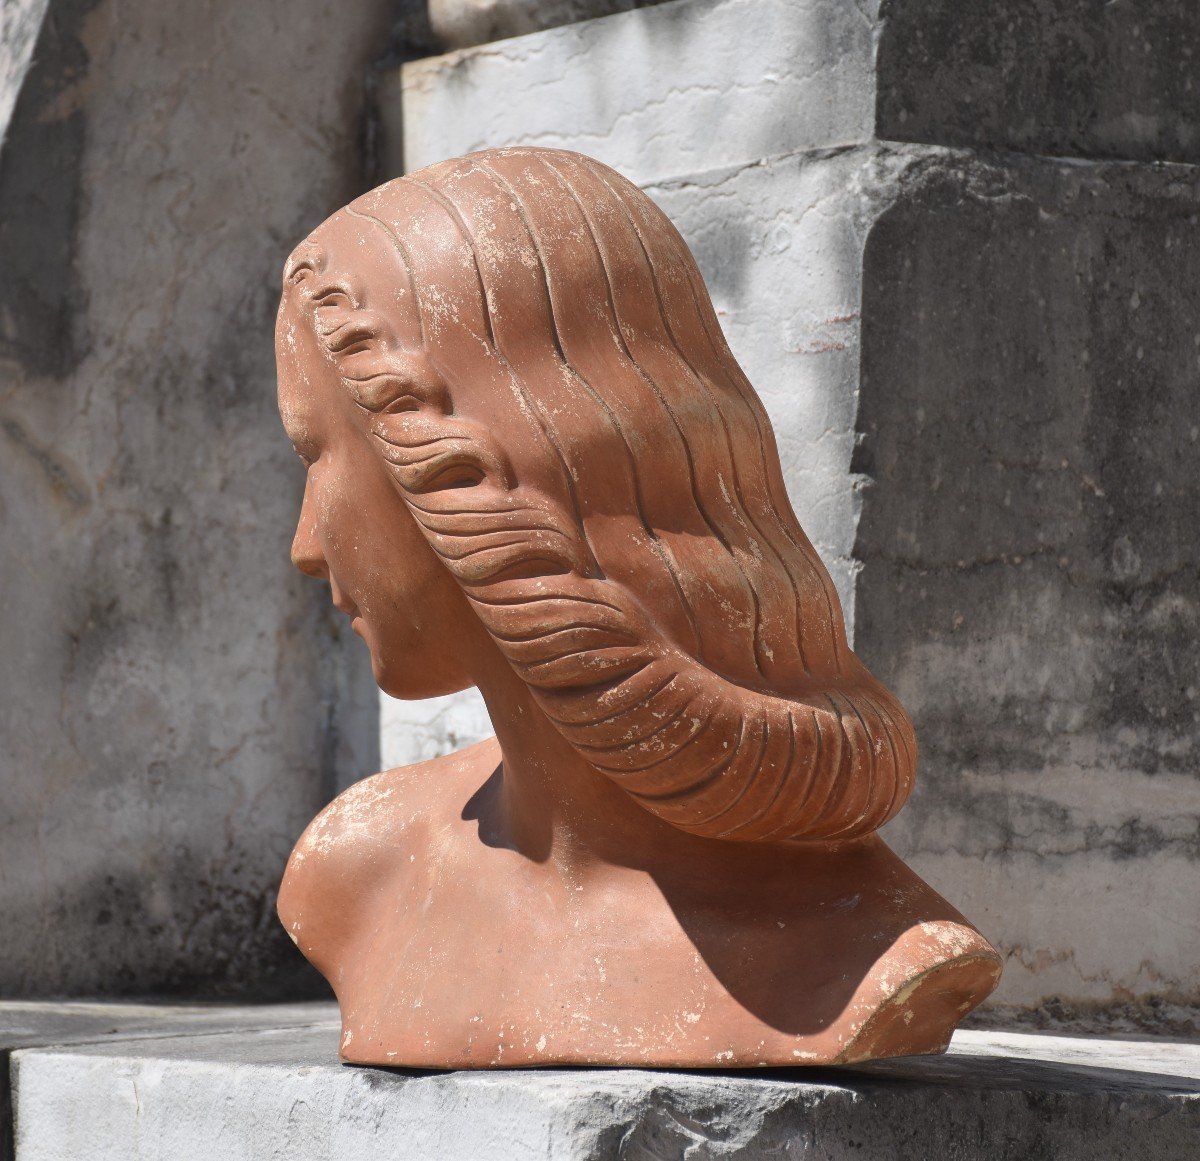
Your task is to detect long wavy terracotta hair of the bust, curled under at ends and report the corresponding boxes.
[284,149,917,841]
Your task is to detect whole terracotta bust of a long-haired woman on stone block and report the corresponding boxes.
[277,149,1000,1067]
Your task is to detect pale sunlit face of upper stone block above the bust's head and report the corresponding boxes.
[398,0,875,185]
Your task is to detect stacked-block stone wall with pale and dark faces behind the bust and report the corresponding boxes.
[383,0,1200,1031]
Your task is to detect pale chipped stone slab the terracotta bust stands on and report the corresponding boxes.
[14,1024,1200,1161]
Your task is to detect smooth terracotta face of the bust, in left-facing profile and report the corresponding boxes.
[276,218,482,698]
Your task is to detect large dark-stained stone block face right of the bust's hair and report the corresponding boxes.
[854,151,1200,1030]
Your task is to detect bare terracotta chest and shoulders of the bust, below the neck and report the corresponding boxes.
[281,744,995,1067]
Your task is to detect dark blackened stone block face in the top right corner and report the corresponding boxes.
[877,0,1200,162]
